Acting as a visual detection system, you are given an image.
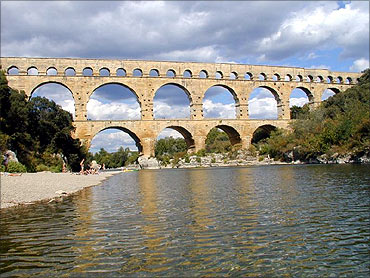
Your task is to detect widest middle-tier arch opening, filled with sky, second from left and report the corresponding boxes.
[86,82,141,120]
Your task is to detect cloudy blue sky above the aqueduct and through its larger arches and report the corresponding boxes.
[0,1,369,152]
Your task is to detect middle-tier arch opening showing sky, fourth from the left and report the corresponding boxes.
[202,84,240,119]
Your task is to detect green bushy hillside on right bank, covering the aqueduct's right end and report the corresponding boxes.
[256,69,370,161]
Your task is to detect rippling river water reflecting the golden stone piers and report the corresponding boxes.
[0,165,370,277]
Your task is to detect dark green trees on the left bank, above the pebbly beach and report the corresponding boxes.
[0,71,87,172]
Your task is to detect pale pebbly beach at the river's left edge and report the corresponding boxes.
[0,171,119,208]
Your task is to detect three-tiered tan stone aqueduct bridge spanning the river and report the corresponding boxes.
[1,57,360,155]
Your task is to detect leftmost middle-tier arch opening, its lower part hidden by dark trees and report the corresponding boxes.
[29,81,76,118]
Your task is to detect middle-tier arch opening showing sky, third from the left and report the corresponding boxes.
[153,82,193,119]
